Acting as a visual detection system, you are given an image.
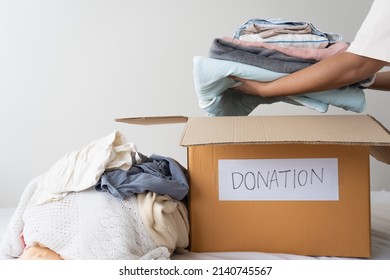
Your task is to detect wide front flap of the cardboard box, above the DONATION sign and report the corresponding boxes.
[181,115,390,163]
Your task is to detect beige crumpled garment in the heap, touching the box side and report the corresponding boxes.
[138,192,189,253]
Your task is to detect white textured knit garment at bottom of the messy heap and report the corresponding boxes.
[0,176,170,260]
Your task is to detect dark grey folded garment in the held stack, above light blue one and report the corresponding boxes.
[209,38,317,73]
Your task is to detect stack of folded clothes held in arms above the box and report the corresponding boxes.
[193,19,373,116]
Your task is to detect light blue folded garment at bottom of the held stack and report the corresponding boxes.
[193,56,366,116]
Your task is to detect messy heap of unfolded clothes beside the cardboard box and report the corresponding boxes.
[0,131,189,260]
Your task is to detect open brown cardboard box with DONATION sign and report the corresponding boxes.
[117,115,390,257]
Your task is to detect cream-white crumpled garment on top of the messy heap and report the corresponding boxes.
[33,131,141,204]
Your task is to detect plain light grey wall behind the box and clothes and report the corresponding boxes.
[0,0,390,207]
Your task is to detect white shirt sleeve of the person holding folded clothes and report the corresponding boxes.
[347,0,390,63]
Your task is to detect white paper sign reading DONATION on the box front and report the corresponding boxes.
[218,158,339,200]
